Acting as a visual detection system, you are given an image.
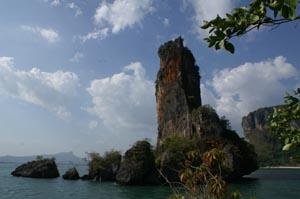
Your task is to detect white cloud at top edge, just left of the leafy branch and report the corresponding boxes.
[183,0,237,39]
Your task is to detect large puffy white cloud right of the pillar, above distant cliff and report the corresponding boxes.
[202,56,300,130]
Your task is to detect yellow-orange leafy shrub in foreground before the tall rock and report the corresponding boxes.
[170,145,254,199]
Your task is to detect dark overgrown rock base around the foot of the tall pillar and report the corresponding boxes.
[157,106,258,182]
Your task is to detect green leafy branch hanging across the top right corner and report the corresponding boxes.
[201,0,300,53]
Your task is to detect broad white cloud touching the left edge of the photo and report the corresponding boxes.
[0,57,79,120]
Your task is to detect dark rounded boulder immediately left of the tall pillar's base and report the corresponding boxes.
[116,141,159,185]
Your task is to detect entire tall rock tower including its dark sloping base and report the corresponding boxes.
[156,37,258,181]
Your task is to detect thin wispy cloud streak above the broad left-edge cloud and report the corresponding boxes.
[21,25,59,43]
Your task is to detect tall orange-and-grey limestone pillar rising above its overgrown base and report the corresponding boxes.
[155,37,201,145]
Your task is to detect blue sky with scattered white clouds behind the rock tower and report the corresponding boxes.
[0,0,300,156]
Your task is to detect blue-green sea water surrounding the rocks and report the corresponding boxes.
[0,163,300,199]
